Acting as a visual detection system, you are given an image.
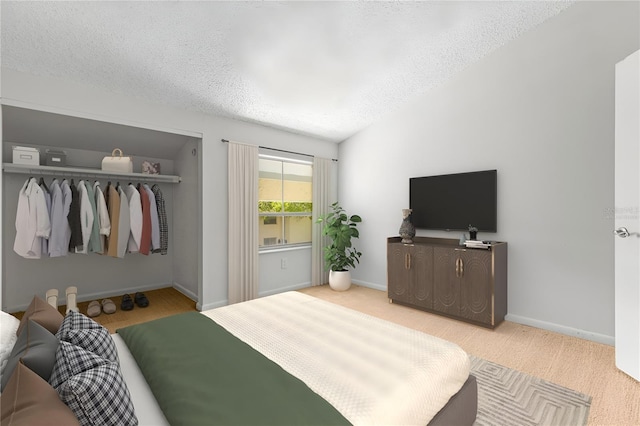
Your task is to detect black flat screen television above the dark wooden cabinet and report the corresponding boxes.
[409,170,498,232]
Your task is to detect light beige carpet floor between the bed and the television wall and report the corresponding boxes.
[300,285,640,426]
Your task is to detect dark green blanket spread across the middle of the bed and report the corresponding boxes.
[117,312,348,426]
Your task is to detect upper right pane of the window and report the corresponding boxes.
[282,162,313,213]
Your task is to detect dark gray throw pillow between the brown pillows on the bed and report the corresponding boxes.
[2,320,59,390]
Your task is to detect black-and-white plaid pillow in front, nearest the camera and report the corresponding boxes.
[50,341,138,426]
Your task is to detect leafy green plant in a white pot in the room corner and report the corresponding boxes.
[317,202,362,291]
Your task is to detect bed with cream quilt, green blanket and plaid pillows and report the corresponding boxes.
[2,292,477,426]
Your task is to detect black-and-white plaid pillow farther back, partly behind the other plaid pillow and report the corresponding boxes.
[56,311,119,362]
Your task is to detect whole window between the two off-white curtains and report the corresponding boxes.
[258,155,313,248]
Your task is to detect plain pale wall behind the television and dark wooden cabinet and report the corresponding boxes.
[339,2,640,344]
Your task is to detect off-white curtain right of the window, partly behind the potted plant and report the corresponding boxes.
[311,157,336,285]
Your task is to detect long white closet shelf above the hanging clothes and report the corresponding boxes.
[2,163,182,183]
